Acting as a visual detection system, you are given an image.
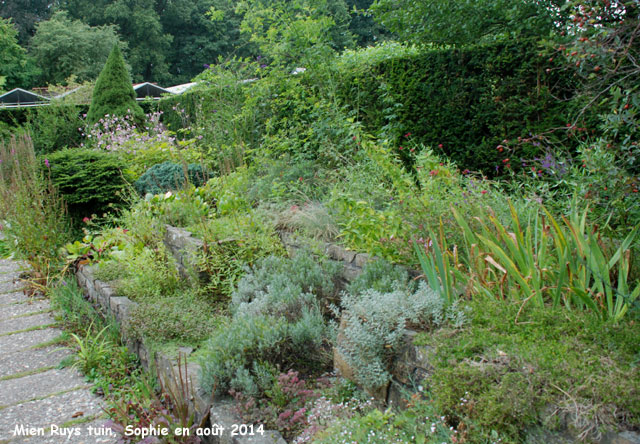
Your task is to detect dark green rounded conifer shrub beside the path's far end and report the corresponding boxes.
[47,148,126,222]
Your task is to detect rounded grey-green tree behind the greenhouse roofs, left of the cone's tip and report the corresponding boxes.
[29,12,126,84]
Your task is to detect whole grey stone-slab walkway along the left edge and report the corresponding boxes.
[0,260,117,444]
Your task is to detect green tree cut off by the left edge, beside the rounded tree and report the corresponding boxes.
[0,18,33,90]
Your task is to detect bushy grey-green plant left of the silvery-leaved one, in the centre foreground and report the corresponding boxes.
[201,252,338,395]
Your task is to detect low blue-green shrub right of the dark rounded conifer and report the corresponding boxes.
[133,162,207,196]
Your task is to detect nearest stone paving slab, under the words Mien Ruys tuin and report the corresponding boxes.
[0,389,102,443]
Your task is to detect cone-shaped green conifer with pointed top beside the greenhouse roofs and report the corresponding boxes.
[87,45,144,124]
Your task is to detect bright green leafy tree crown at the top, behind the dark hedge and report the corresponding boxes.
[371,0,568,46]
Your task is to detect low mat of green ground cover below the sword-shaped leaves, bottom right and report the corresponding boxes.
[416,301,640,442]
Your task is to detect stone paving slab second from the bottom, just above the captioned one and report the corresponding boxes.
[0,368,87,411]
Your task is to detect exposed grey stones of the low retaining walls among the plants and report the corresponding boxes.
[77,226,640,444]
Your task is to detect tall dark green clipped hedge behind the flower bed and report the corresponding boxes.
[339,41,592,175]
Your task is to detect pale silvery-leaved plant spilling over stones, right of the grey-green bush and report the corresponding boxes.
[338,282,466,389]
